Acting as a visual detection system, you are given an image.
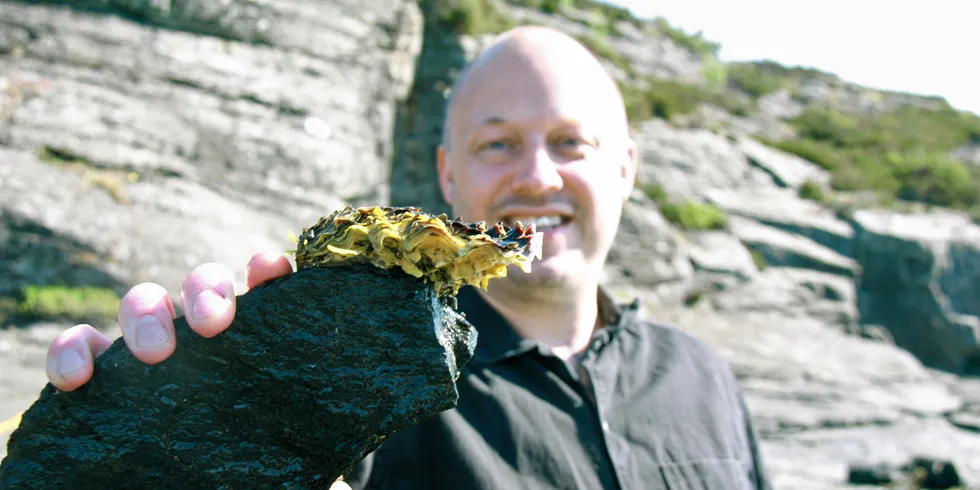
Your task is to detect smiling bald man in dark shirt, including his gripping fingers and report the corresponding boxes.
[42,27,768,490]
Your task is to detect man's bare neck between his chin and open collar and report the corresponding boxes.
[478,280,599,360]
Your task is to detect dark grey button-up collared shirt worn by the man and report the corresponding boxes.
[346,288,770,490]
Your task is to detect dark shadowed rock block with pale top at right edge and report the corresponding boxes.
[854,210,980,372]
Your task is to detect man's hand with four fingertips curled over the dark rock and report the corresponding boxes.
[46,253,293,391]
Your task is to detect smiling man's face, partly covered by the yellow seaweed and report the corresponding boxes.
[439,43,634,285]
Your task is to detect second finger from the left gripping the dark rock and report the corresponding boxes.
[119,282,177,364]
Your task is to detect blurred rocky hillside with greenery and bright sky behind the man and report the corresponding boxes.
[0,0,980,489]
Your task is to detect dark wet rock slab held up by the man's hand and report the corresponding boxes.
[0,266,476,489]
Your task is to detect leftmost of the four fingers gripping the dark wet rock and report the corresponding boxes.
[45,324,112,391]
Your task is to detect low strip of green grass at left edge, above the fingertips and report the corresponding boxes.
[0,286,121,326]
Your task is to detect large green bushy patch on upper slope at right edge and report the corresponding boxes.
[765,106,980,210]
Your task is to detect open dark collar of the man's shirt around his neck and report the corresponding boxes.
[456,286,639,364]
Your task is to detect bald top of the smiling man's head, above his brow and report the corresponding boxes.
[443,26,629,148]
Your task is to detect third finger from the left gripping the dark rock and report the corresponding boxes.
[180,263,235,338]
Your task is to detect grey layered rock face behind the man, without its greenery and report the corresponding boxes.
[0,0,980,489]
